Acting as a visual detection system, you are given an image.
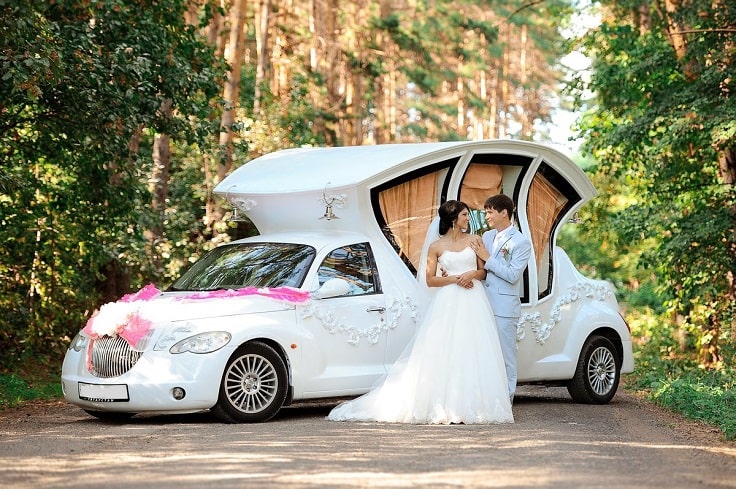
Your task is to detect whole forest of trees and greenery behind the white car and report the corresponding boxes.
[0,0,736,439]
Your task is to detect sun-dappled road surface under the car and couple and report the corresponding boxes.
[0,387,736,489]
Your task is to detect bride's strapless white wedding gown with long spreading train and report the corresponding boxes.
[327,247,514,424]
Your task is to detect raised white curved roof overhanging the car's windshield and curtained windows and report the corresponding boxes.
[214,139,596,237]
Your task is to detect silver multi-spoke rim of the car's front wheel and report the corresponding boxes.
[225,354,279,414]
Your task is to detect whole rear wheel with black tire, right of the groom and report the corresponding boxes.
[567,336,621,404]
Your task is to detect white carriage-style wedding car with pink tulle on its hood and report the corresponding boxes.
[62,140,634,422]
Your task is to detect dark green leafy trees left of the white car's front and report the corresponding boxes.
[0,0,221,365]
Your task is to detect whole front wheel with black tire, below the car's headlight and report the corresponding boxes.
[211,341,288,423]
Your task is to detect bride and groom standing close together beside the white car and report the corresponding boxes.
[327,194,531,424]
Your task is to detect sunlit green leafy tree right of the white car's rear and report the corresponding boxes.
[580,4,736,366]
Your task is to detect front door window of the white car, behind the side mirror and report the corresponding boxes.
[317,243,380,295]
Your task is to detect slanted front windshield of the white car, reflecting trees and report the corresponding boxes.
[169,243,316,291]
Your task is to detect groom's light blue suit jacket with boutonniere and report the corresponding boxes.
[483,226,532,318]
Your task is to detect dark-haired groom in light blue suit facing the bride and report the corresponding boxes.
[475,194,532,402]
